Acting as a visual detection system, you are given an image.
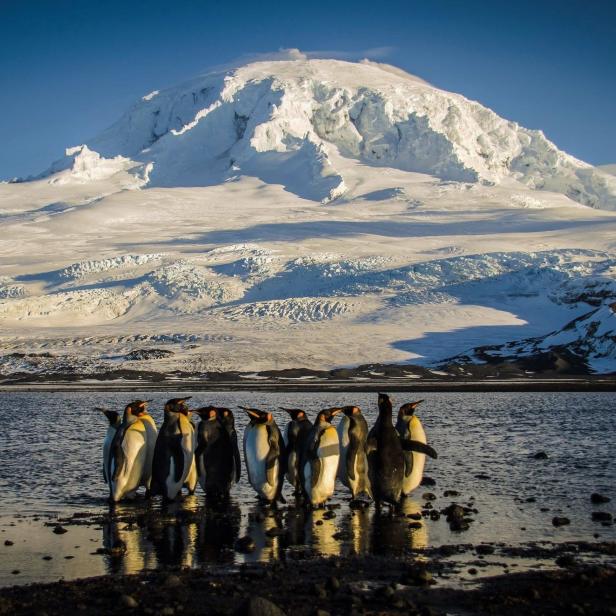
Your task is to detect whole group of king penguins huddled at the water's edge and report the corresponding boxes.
[99,394,437,507]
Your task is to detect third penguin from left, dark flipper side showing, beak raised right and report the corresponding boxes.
[150,396,194,501]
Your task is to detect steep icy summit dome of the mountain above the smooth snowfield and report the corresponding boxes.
[37,60,616,210]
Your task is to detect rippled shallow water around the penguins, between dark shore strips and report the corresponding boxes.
[0,391,616,585]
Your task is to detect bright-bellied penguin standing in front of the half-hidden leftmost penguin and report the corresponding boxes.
[107,404,147,503]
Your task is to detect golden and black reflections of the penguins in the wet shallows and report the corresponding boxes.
[98,496,428,574]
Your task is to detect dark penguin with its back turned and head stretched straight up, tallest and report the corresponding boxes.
[367,394,404,507]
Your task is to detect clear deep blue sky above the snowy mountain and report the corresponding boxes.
[0,0,616,178]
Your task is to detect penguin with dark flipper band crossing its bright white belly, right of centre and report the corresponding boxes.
[301,408,341,507]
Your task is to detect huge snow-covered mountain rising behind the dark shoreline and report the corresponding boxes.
[0,56,616,373]
